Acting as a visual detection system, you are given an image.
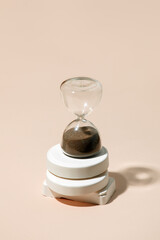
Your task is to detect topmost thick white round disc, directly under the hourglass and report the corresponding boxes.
[47,144,109,179]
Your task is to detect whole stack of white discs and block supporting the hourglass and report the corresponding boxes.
[43,144,115,204]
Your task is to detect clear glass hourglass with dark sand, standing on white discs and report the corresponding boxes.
[60,77,102,158]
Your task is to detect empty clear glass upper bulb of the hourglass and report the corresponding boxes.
[60,77,102,117]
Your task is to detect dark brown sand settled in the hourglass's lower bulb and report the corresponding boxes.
[61,126,101,158]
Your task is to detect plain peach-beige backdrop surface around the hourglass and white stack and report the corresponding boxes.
[0,0,160,240]
